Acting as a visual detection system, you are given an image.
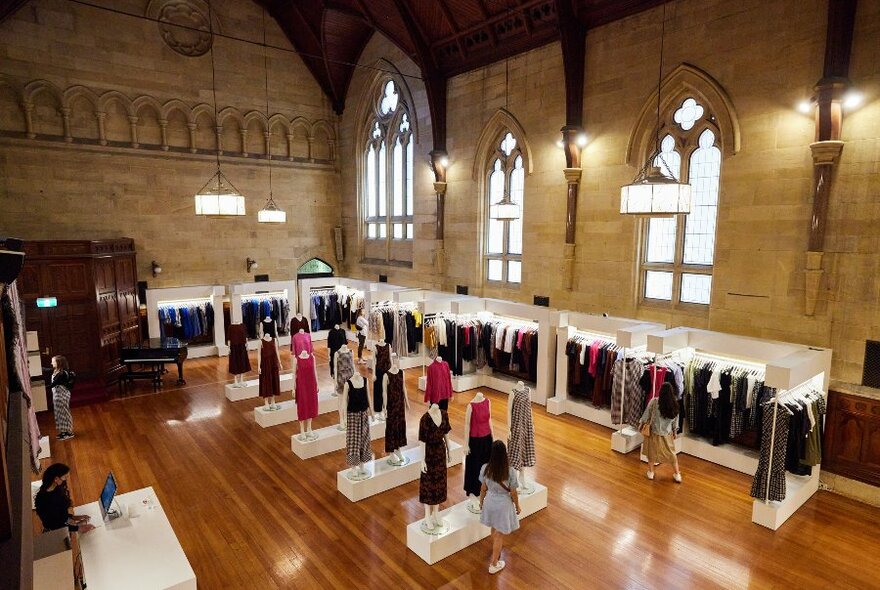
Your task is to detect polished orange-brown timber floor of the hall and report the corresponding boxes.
[40,345,880,590]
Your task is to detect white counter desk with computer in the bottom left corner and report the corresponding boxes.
[76,487,196,590]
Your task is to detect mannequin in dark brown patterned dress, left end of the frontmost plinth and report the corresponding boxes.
[419,404,451,535]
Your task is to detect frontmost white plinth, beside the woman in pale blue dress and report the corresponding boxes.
[406,483,547,565]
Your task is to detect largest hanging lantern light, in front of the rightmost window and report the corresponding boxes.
[620,4,691,217]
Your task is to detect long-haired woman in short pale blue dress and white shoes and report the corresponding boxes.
[480,440,522,574]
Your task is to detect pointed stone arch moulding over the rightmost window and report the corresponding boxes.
[626,64,741,168]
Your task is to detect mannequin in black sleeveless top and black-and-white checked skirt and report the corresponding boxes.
[339,373,373,480]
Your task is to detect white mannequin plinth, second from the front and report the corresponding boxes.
[336,440,464,502]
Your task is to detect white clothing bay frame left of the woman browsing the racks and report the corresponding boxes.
[547,312,666,428]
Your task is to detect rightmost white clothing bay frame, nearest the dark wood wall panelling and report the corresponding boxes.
[647,328,831,530]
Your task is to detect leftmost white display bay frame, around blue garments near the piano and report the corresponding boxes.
[146,285,229,358]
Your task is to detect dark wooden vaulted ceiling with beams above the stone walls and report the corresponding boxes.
[256,0,664,112]
